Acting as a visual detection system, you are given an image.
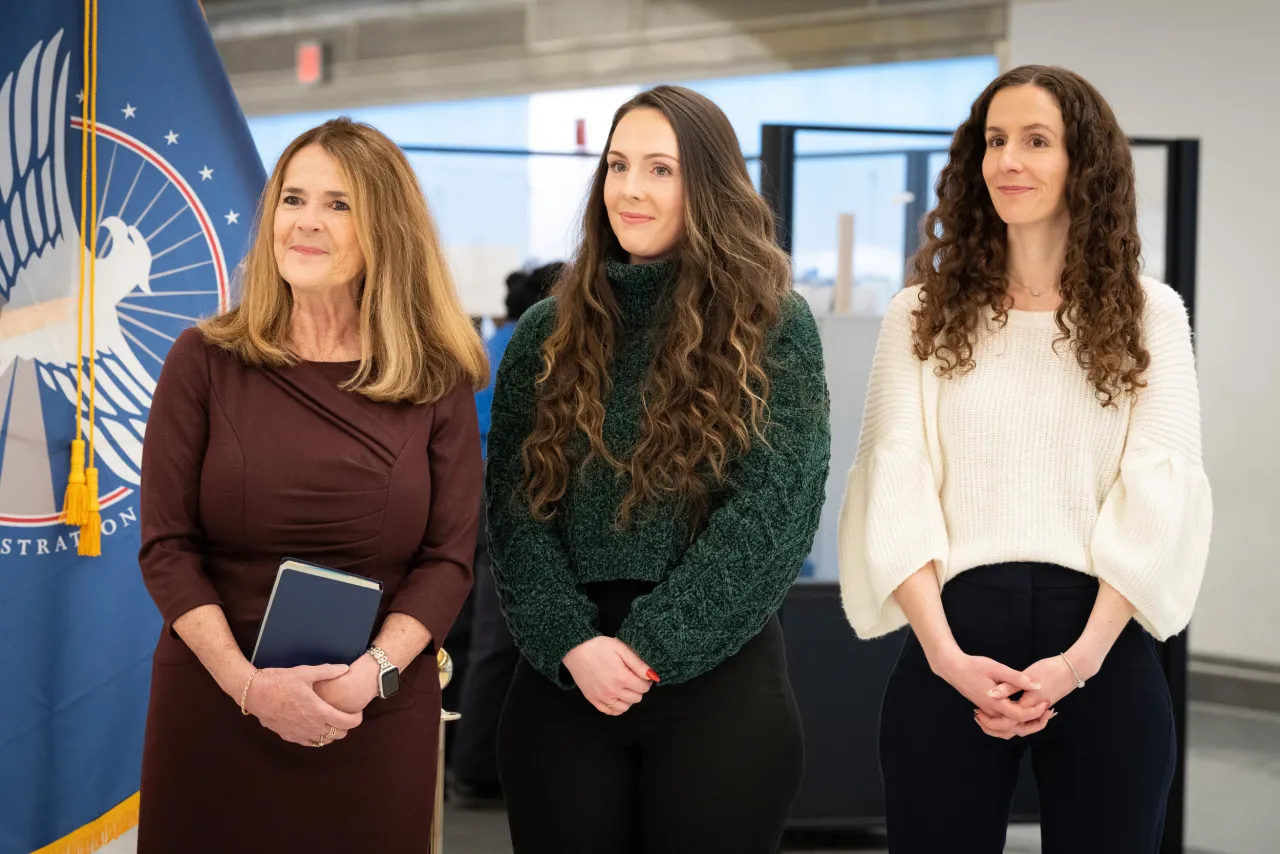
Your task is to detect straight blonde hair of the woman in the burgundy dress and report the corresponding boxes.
[200,118,489,403]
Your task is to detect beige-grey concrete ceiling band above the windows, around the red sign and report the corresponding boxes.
[204,0,1009,114]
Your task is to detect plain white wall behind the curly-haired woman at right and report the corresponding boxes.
[1009,0,1280,663]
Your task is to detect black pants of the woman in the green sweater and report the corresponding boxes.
[498,581,804,854]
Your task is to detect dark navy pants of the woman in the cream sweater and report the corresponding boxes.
[881,563,1176,854]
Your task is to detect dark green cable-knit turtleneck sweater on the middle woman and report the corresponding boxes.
[486,261,831,689]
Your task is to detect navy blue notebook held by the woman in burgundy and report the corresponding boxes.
[252,557,383,670]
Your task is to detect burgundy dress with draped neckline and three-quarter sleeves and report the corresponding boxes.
[138,323,481,854]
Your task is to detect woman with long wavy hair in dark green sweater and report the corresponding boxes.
[486,86,829,854]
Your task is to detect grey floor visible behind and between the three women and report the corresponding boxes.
[94,705,1280,854]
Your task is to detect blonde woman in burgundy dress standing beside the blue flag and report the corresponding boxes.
[138,119,488,854]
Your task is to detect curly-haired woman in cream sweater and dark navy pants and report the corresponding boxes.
[840,67,1211,854]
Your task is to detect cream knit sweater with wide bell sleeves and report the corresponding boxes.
[838,279,1212,640]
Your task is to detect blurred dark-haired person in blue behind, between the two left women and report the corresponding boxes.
[448,261,564,808]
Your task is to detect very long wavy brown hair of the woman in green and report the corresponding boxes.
[522,86,791,528]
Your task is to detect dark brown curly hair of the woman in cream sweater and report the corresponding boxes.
[910,65,1151,407]
